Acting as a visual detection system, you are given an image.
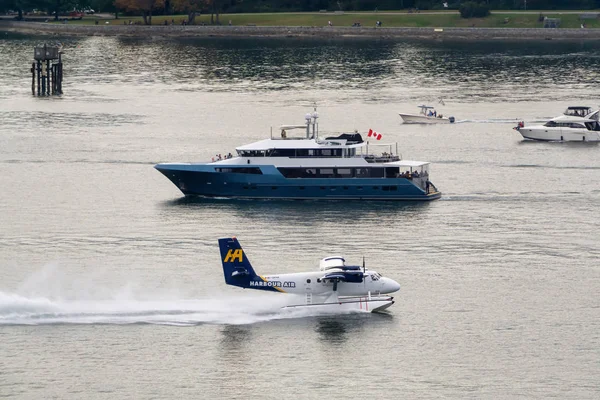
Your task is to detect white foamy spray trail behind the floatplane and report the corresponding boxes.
[0,291,366,326]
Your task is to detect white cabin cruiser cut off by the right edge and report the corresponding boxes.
[515,107,600,142]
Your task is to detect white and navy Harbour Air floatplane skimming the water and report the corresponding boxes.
[219,237,400,313]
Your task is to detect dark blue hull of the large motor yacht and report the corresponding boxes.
[157,167,441,201]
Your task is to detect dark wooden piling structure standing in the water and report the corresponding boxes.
[31,44,63,96]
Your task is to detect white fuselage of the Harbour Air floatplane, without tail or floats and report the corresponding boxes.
[250,270,400,296]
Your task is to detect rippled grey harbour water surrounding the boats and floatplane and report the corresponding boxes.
[0,33,600,399]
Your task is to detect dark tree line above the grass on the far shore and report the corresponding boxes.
[0,0,600,23]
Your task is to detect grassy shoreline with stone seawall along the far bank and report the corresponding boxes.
[0,12,600,40]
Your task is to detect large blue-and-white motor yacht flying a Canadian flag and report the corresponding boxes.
[155,110,442,201]
